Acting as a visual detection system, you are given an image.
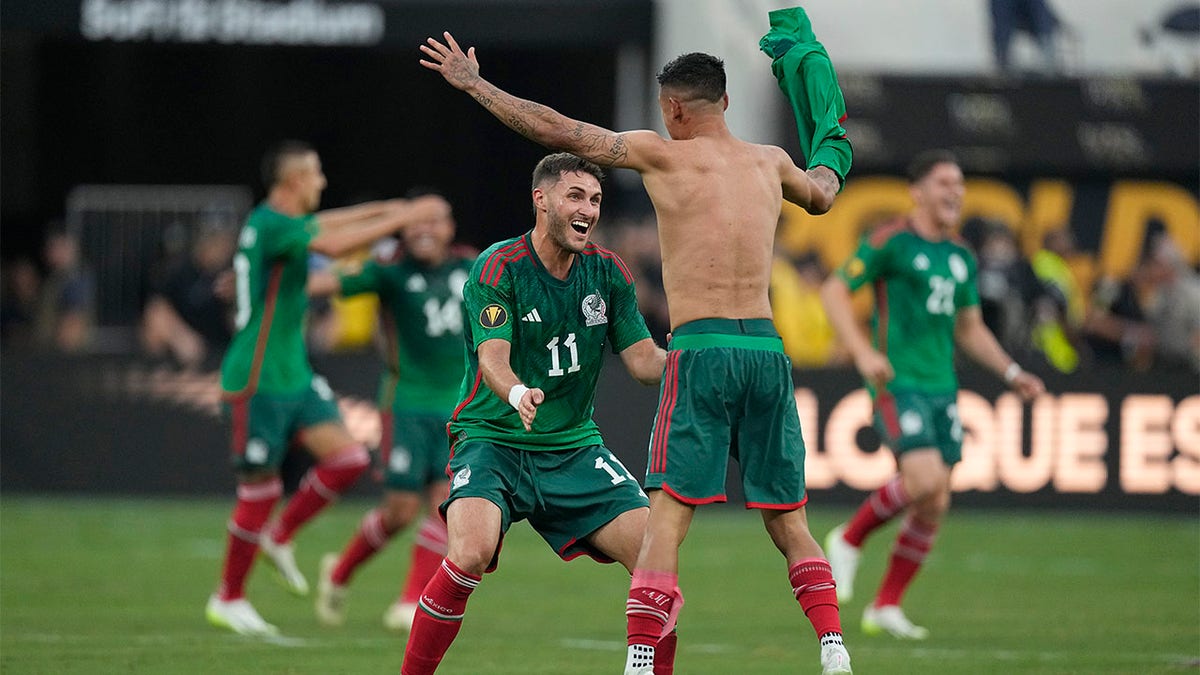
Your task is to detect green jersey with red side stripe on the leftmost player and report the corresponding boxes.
[221,203,317,395]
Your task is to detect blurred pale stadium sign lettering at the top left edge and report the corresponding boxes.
[79,0,384,46]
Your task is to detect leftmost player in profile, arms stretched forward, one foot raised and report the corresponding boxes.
[205,141,436,635]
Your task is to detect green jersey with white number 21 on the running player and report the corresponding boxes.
[838,219,979,394]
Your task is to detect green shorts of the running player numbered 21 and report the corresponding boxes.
[875,392,962,466]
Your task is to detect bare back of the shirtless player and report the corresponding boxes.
[642,133,782,328]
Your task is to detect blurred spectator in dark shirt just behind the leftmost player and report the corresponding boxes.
[140,221,238,370]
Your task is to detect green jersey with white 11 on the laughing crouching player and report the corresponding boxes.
[450,233,650,450]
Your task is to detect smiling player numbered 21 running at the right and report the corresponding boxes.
[821,150,1045,640]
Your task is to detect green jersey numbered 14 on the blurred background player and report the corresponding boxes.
[341,253,474,416]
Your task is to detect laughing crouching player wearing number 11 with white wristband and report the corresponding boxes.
[401,153,673,675]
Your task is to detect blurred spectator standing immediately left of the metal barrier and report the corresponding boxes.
[34,223,96,352]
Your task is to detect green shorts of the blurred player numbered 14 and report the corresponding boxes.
[379,408,450,492]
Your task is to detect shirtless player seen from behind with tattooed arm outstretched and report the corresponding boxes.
[421,18,851,675]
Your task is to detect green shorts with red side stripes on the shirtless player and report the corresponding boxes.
[646,318,808,510]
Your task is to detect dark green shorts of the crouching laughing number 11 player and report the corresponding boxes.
[442,441,649,569]
